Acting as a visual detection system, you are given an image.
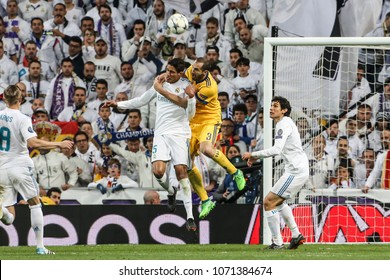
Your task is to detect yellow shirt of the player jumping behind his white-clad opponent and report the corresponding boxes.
[186,65,221,124]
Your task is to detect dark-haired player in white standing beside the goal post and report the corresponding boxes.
[242,96,309,250]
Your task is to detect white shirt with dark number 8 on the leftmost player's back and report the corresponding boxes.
[0,108,37,168]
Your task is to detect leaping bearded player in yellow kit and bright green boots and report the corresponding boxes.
[154,58,245,219]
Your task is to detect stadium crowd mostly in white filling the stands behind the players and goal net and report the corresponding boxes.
[0,0,390,206]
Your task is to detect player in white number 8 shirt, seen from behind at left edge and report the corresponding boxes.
[0,85,73,255]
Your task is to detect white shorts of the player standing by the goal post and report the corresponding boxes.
[271,173,309,199]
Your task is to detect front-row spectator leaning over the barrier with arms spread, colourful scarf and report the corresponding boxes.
[88,158,138,194]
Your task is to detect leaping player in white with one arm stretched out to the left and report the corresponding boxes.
[106,58,196,231]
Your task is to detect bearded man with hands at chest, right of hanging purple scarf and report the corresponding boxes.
[58,87,97,124]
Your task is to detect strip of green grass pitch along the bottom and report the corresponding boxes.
[0,244,390,260]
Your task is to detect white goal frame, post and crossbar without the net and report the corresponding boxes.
[262,37,390,244]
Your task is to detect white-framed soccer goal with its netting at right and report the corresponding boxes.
[262,37,390,244]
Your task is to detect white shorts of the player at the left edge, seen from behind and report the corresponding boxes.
[0,167,39,207]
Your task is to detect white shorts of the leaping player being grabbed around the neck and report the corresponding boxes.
[152,135,190,166]
